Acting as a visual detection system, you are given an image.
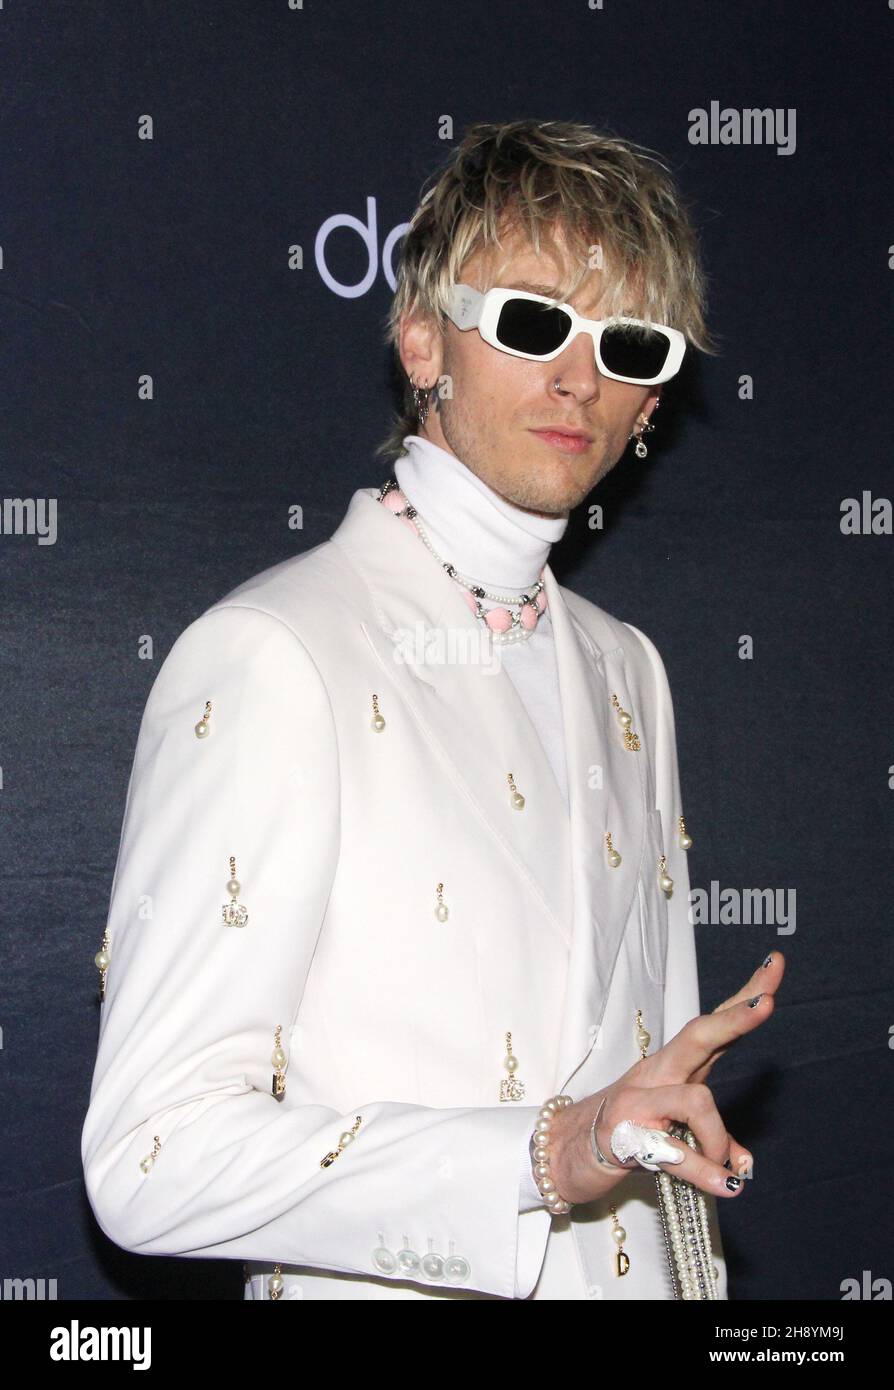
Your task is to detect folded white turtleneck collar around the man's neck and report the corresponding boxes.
[392,435,569,594]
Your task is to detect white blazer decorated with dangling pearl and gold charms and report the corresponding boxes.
[82,488,727,1298]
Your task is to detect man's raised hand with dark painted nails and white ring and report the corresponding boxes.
[549,951,786,1204]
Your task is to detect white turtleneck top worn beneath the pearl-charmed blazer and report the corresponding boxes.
[393,435,571,1228]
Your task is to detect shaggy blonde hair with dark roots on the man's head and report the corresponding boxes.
[375,121,717,459]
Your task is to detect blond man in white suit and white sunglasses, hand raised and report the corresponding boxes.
[82,122,783,1298]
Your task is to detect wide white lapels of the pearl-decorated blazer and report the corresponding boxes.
[332,488,647,1090]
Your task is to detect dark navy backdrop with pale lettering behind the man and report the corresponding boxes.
[0,0,894,1300]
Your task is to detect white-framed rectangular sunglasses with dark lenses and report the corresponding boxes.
[448,285,685,386]
